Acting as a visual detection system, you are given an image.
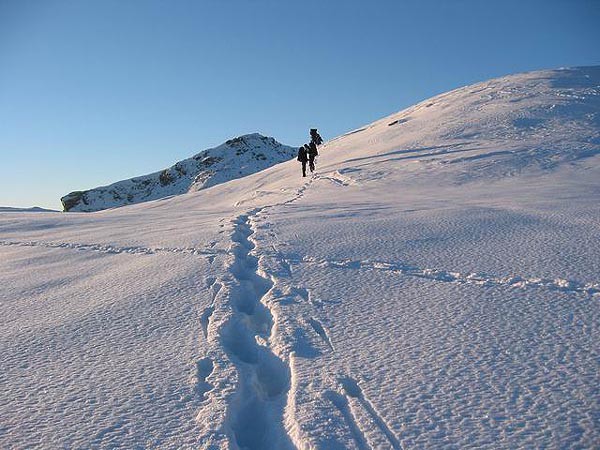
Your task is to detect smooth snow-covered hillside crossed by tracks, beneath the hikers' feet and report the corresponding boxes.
[0,68,600,450]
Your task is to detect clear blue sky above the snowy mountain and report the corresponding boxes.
[0,0,600,209]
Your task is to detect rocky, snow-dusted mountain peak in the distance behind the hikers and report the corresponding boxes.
[60,133,296,212]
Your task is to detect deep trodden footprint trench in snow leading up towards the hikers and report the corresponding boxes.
[221,210,294,450]
